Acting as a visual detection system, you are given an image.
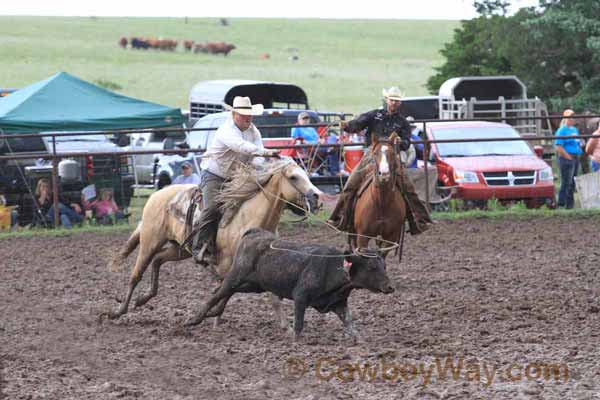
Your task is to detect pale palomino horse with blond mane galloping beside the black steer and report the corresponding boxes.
[103,158,322,327]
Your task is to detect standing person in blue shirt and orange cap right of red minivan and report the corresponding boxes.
[554,109,583,209]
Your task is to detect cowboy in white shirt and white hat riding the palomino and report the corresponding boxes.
[192,96,279,262]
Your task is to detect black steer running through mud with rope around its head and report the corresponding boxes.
[186,228,394,339]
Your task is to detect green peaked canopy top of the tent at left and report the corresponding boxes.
[0,72,183,133]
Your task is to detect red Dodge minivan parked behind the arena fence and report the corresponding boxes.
[427,121,554,207]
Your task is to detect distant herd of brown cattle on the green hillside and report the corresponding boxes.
[119,36,235,56]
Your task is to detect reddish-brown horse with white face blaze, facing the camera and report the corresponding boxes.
[350,133,406,258]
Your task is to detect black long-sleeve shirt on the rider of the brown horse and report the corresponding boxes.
[344,108,411,150]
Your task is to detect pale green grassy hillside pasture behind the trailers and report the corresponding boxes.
[0,16,458,112]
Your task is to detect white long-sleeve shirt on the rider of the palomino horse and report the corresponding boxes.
[200,118,265,179]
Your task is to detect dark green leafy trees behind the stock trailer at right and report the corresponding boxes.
[427,0,600,112]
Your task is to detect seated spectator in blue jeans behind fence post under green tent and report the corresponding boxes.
[34,178,83,229]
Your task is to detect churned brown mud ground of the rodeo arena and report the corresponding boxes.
[0,218,600,400]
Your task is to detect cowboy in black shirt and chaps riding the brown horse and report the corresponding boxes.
[329,87,431,235]
